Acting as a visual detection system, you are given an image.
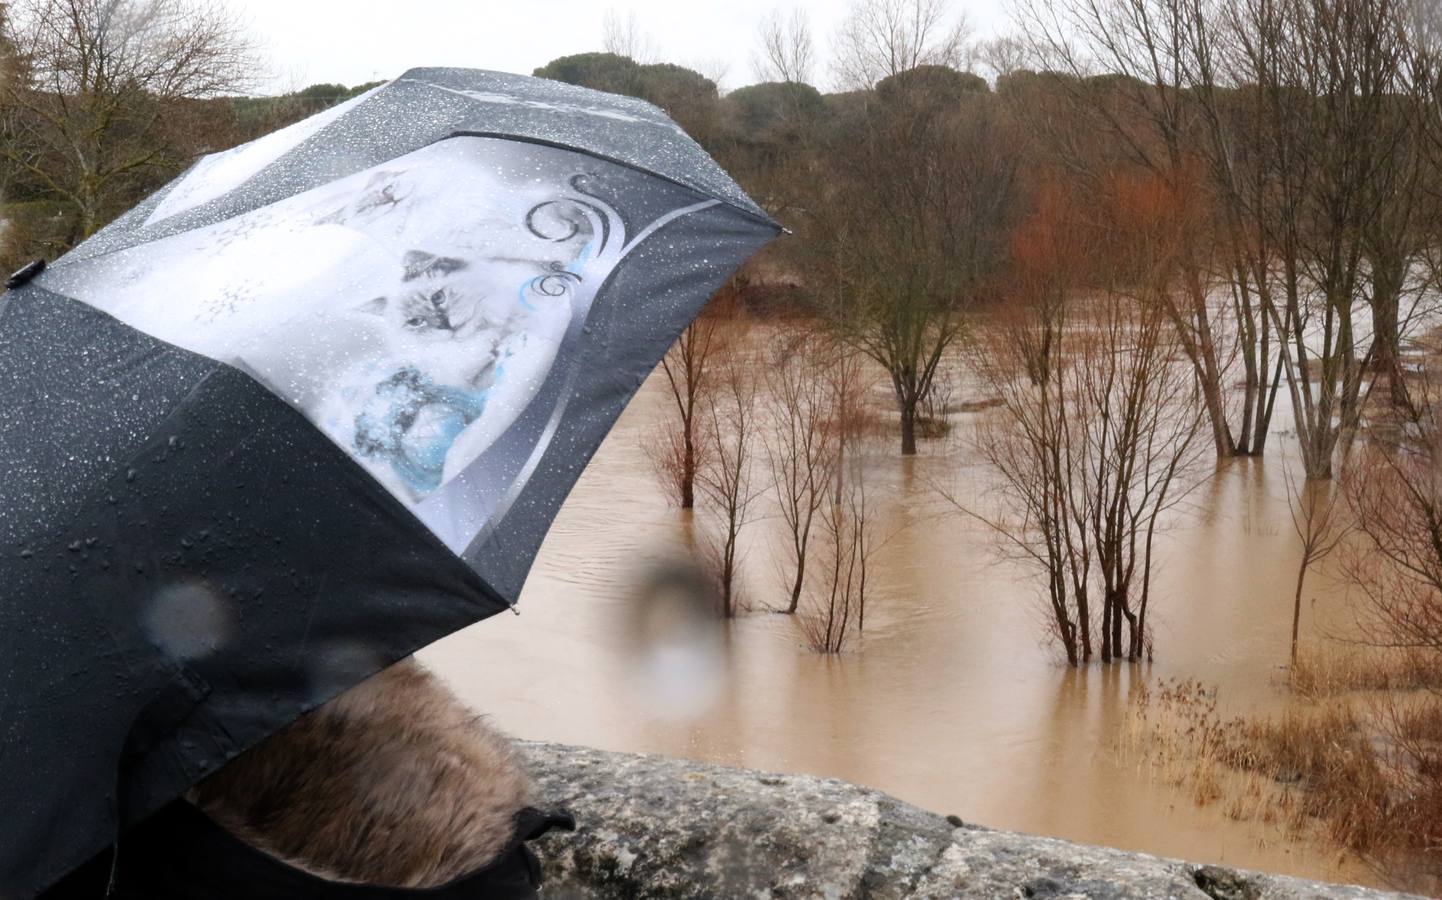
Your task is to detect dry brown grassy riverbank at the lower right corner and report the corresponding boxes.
[1126,645,1442,896]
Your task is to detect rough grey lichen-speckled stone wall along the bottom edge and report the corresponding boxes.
[523,744,1418,900]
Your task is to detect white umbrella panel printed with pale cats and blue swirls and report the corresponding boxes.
[43,137,608,505]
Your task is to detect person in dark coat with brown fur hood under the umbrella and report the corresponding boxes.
[43,661,575,900]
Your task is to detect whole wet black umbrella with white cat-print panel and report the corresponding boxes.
[0,69,777,899]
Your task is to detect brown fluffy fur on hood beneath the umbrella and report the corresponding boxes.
[189,659,535,887]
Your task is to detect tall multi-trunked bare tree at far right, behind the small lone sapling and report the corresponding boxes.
[1223,0,1417,479]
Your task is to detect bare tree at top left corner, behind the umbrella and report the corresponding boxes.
[0,0,257,239]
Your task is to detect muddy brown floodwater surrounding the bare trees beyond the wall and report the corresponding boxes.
[423,340,1377,884]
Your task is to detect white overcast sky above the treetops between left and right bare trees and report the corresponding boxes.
[242,0,1005,92]
